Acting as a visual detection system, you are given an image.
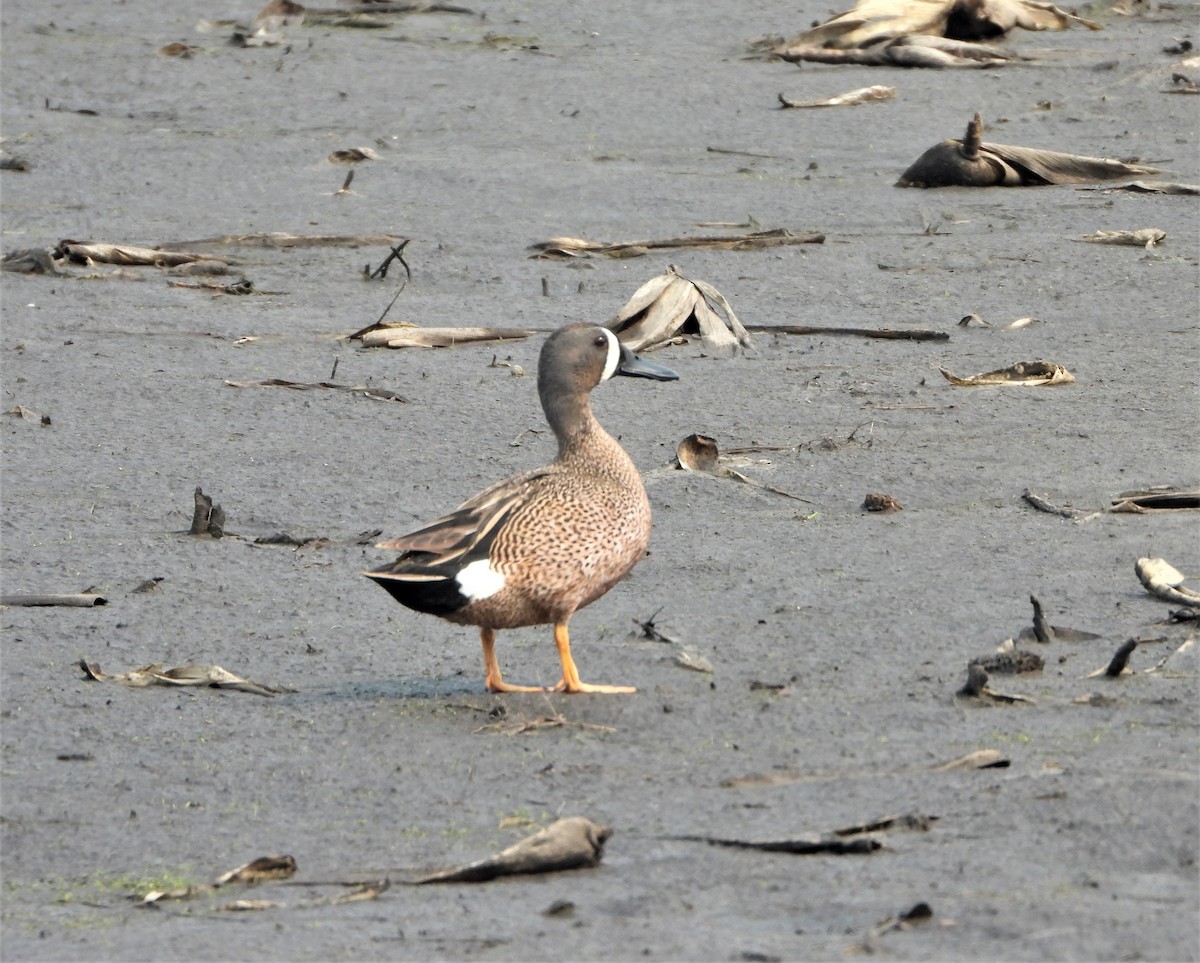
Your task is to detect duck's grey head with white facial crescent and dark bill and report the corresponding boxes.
[538,324,679,399]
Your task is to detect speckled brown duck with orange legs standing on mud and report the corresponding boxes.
[362,323,679,694]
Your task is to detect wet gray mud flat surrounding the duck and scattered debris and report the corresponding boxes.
[0,0,1200,961]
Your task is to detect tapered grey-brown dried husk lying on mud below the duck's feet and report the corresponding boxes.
[415,817,612,885]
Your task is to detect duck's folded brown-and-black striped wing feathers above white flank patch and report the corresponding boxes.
[376,468,551,566]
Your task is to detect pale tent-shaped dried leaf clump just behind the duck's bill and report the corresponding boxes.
[607,264,750,353]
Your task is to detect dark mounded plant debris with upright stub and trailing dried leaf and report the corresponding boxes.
[896,114,1160,187]
